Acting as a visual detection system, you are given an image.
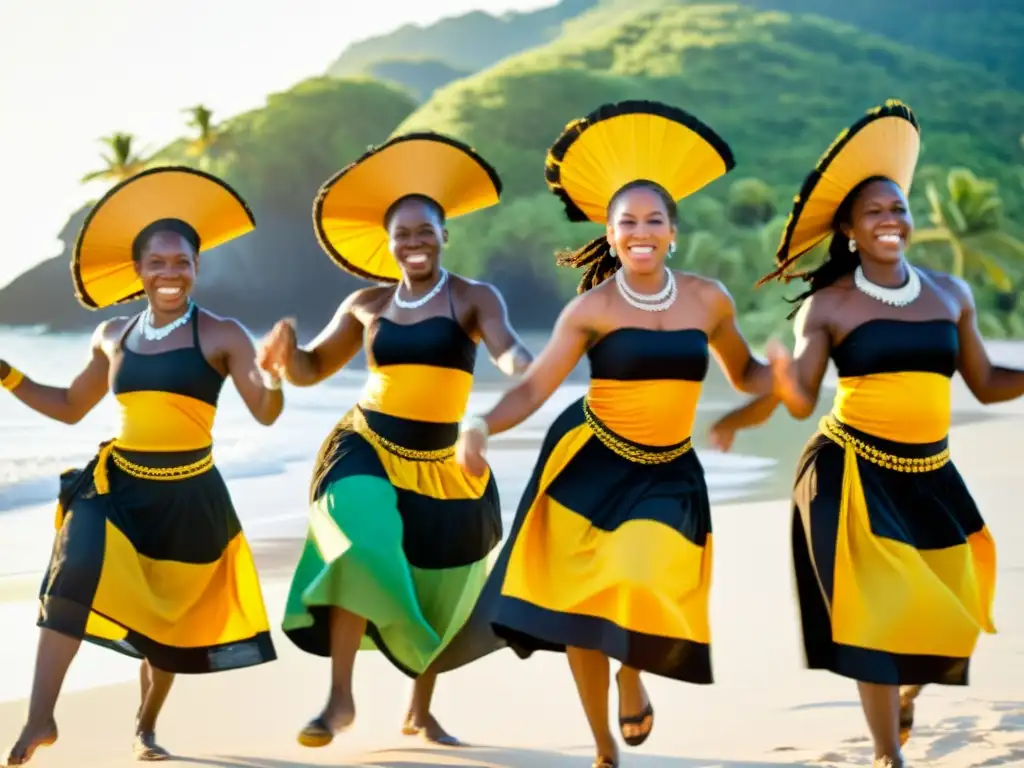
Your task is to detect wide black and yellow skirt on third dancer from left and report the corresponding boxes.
[441,399,713,684]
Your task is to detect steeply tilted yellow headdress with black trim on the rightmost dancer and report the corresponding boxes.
[762,99,921,282]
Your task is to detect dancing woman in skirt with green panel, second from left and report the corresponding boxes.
[260,133,531,746]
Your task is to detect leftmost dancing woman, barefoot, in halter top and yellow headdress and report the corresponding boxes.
[0,168,284,766]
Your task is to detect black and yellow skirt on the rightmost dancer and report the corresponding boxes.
[793,416,995,685]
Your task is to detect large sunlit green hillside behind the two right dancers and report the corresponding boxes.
[396,3,1024,333]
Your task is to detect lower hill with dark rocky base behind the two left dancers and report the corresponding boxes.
[0,77,416,330]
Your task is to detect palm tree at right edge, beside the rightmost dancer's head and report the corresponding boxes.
[913,168,1024,291]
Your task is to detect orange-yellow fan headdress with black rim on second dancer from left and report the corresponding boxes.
[313,132,502,283]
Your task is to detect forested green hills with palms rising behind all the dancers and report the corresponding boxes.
[0,0,1024,339]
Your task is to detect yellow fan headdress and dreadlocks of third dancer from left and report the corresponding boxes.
[545,100,735,293]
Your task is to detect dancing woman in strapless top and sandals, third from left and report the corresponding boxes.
[458,101,798,768]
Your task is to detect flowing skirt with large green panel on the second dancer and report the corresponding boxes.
[283,407,502,678]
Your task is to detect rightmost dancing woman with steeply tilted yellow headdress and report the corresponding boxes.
[713,101,1003,766]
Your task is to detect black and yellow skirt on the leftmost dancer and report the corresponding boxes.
[38,443,276,674]
